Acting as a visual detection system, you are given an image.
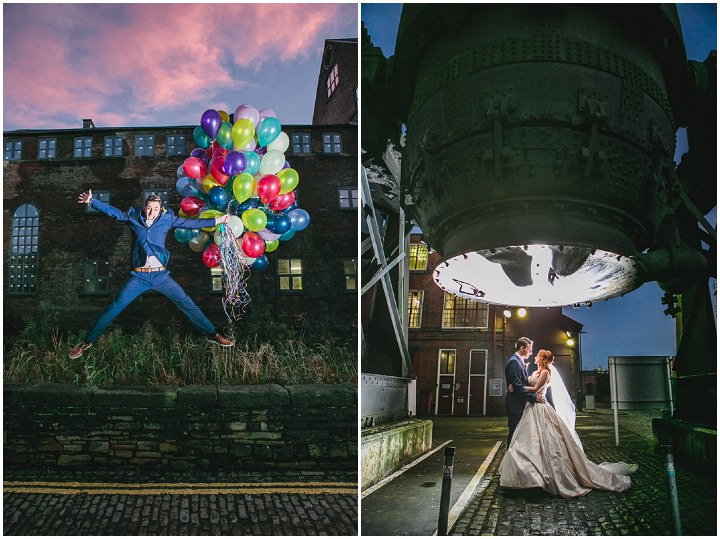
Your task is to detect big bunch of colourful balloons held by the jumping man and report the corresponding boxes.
[175,104,310,270]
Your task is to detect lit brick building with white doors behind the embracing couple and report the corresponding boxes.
[408,234,582,416]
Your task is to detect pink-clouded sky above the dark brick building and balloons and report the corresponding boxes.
[3,3,357,130]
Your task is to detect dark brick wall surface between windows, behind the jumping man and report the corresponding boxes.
[3,125,357,345]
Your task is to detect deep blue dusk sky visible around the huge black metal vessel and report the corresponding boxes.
[360,3,717,370]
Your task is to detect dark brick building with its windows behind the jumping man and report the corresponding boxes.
[3,42,358,346]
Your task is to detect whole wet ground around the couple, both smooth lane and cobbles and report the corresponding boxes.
[361,410,717,537]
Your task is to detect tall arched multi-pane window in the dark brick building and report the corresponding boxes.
[8,204,40,294]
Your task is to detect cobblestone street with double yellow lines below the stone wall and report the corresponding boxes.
[3,469,358,536]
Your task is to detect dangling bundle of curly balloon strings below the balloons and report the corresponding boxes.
[219,225,250,325]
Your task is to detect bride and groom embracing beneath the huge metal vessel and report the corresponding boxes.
[500,337,637,498]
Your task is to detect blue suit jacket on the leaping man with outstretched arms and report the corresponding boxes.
[90,198,215,268]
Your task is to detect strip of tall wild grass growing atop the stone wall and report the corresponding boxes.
[3,323,358,387]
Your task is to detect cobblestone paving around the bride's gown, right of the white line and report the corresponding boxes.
[450,411,717,537]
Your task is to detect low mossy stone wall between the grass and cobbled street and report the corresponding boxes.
[3,384,358,470]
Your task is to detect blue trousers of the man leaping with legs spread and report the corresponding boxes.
[85,270,216,343]
